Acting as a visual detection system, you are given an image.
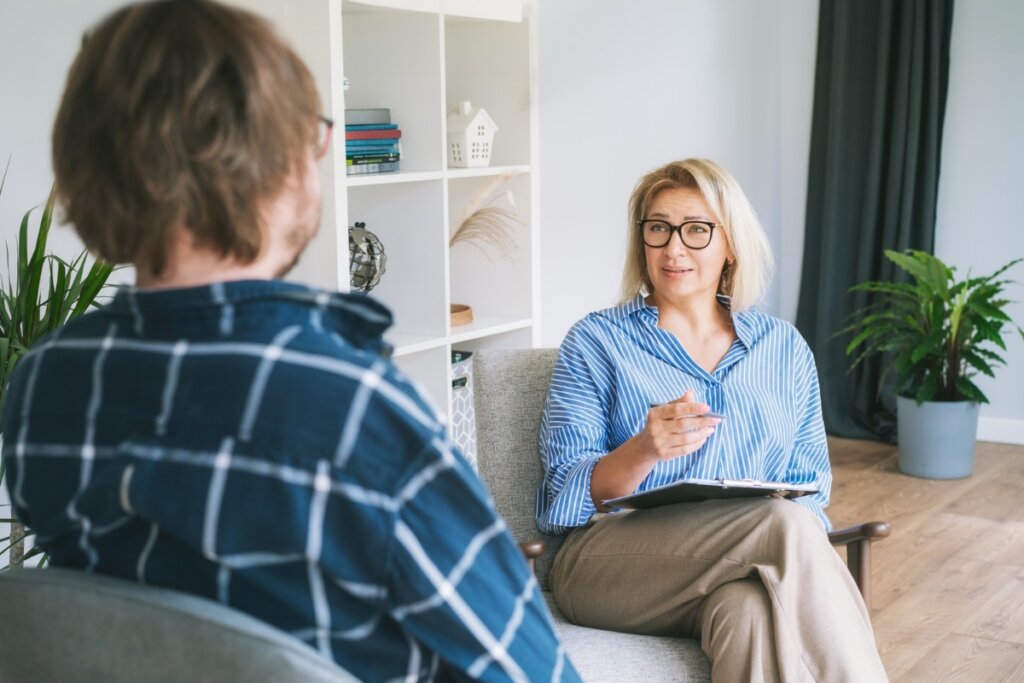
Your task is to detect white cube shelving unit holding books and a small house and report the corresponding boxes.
[242,0,540,413]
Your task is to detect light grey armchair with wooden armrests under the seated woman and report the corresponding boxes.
[473,349,889,682]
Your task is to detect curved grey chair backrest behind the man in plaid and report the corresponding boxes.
[0,568,355,683]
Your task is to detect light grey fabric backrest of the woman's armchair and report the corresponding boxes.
[473,348,562,590]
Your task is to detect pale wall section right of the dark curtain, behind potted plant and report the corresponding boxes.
[935,0,1024,443]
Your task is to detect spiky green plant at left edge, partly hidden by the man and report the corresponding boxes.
[0,178,114,570]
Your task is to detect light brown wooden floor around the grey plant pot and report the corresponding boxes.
[829,439,1024,683]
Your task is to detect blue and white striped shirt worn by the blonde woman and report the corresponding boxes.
[537,296,831,533]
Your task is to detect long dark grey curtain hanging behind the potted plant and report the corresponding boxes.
[797,0,953,440]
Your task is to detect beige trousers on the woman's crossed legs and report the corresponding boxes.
[550,499,887,683]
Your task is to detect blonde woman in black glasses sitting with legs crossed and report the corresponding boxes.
[538,159,886,683]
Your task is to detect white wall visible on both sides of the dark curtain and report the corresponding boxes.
[540,0,1024,443]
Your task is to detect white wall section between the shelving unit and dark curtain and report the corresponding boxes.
[539,0,817,345]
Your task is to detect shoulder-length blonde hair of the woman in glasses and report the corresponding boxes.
[622,159,774,311]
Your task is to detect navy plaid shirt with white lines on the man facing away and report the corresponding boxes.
[3,282,579,681]
